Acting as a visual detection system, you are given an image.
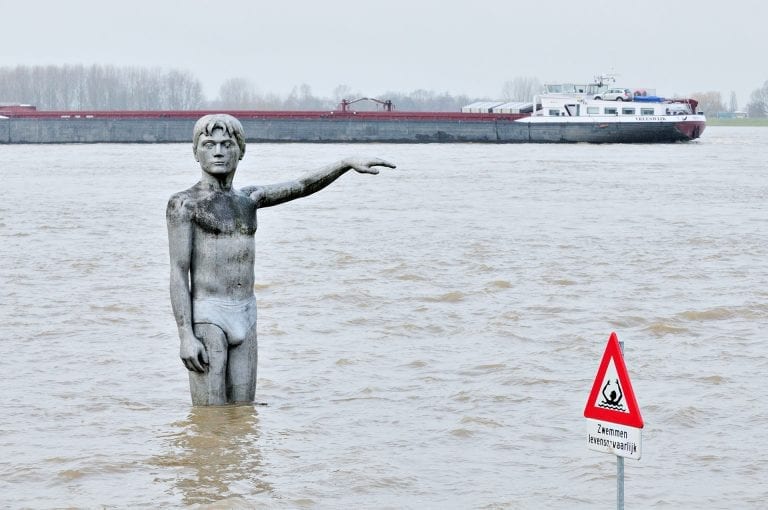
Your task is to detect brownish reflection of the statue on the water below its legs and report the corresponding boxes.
[150,405,272,505]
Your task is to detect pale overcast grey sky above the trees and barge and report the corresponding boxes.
[0,0,768,108]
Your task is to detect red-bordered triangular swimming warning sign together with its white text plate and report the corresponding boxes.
[584,333,643,459]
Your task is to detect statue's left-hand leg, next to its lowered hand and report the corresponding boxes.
[189,324,227,406]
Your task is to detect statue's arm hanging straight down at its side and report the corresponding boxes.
[165,195,208,372]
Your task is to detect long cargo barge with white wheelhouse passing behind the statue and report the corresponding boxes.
[0,94,706,144]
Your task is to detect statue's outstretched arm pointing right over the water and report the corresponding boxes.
[242,158,395,207]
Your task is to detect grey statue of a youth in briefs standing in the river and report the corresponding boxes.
[166,115,395,405]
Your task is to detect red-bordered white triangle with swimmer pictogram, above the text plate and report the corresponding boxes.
[584,333,643,429]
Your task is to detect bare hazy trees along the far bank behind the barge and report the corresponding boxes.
[6,65,768,117]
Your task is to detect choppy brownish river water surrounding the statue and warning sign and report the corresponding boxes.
[0,127,768,509]
